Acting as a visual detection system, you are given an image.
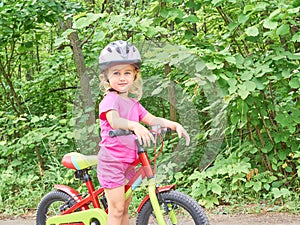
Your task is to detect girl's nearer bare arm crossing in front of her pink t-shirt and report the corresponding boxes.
[106,110,154,146]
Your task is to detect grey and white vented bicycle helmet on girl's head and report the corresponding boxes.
[99,40,142,72]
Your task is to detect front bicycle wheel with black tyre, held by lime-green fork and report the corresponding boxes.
[136,190,209,225]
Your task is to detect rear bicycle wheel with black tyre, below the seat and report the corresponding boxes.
[36,190,75,225]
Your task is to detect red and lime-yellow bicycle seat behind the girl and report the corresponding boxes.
[62,152,98,170]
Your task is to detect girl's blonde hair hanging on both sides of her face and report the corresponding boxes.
[99,65,143,101]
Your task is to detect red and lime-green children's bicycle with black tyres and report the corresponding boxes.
[36,128,209,225]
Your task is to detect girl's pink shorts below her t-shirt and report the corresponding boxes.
[97,156,135,188]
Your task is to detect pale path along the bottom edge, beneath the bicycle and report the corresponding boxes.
[0,213,300,225]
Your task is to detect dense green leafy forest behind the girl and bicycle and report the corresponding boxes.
[0,0,300,215]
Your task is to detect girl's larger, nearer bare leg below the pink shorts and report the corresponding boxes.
[104,186,128,225]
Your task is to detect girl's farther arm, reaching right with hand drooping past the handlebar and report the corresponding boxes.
[142,113,190,145]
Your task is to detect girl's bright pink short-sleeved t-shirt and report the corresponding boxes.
[99,92,147,163]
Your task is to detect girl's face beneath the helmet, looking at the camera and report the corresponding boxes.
[107,64,136,93]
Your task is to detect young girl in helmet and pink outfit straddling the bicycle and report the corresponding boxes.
[97,41,190,225]
